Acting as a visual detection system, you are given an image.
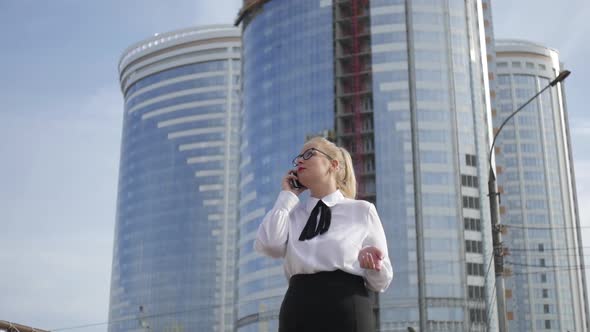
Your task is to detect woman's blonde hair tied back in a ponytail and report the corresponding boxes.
[305,136,356,199]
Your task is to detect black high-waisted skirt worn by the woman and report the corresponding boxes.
[279,270,376,332]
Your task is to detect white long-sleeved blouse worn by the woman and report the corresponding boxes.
[254,190,393,292]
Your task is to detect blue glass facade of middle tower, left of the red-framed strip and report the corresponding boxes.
[237,0,334,332]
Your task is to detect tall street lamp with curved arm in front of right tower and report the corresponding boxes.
[488,70,571,332]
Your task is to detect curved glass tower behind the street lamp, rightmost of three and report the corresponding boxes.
[494,40,588,331]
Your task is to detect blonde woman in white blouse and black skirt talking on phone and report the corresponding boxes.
[254,137,393,332]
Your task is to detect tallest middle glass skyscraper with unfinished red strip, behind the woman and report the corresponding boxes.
[237,0,497,332]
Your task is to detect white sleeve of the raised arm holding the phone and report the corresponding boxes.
[254,190,299,258]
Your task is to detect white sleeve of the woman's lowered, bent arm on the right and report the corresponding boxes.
[363,204,393,292]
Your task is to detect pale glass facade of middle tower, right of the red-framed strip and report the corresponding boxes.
[371,0,495,331]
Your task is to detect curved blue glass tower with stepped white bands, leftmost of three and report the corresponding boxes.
[109,26,241,332]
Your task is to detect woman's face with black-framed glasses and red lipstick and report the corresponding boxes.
[296,144,332,187]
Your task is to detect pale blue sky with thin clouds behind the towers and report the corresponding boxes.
[0,0,590,332]
